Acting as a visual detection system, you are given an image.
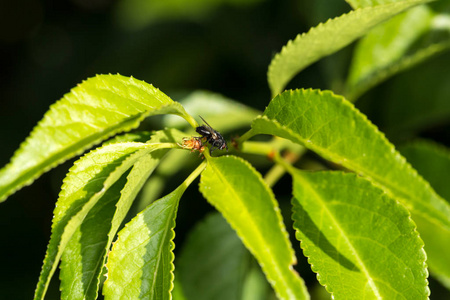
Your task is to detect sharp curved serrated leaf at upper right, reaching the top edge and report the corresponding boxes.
[267,0,429,96]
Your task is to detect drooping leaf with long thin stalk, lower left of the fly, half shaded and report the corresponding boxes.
[103,163,205,299]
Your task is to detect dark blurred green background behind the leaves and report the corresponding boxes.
[0,0,450,299]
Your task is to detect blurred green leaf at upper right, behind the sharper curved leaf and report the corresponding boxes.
[346,5,450,100]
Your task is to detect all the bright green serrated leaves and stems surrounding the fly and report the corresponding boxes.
[0,0,450,299]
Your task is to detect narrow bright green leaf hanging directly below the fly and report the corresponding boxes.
[200,156,309,299]
